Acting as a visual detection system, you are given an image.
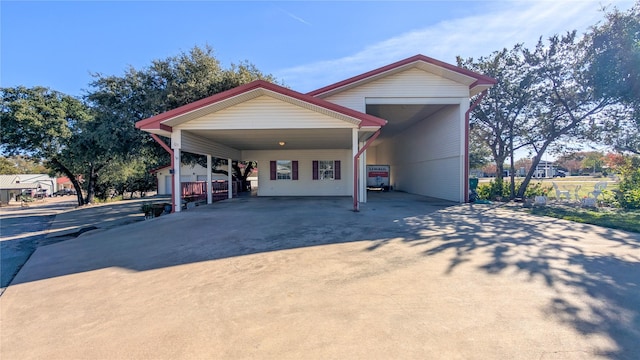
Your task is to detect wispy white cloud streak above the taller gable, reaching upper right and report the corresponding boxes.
[274,1,633,92]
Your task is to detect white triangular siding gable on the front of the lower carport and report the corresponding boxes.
[179,96,356,130]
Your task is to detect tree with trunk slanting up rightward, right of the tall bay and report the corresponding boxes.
[517,31,615,197]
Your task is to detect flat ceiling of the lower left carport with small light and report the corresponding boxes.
[192,129,351,150]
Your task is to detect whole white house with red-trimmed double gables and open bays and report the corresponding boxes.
[136,55,496,211]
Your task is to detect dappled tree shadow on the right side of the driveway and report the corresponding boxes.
[380,205,640,359]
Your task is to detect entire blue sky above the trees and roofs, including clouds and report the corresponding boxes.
[0,0,633,96]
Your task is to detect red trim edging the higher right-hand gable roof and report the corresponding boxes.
[307,54,498,96]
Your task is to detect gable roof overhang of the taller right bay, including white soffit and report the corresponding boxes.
[307,54,497,97]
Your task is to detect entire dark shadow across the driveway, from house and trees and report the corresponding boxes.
[5,193,640,359]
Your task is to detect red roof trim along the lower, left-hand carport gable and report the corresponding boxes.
[136,80,387,130]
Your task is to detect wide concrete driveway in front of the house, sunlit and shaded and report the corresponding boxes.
[0,193,640,359]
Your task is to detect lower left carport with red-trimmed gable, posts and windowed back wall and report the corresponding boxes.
[136,80,386,211]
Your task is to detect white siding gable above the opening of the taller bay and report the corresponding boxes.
[324,68,469,112]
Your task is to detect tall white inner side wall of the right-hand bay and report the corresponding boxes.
[367,105,463,201]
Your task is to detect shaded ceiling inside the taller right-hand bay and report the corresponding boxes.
[367,104,447,139]
